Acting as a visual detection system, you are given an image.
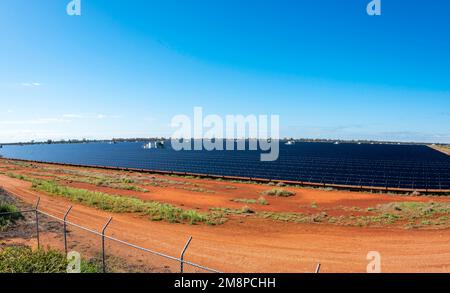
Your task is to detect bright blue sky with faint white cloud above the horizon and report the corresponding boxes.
[0,0,450,142]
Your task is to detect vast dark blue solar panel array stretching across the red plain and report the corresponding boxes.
[0,143,450,190]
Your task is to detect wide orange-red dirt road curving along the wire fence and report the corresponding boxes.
[0,175,450,273]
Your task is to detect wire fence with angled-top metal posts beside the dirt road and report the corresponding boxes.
[0,197,219,273]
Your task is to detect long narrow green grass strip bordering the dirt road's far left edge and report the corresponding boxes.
[10,174,222,224]
